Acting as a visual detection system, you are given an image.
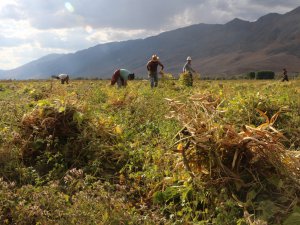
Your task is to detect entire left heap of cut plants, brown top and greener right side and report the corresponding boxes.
[14,100,124,176]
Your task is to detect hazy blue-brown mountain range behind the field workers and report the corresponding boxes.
[0,7,300,79]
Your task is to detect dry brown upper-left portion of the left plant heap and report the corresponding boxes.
[20,101,85,160]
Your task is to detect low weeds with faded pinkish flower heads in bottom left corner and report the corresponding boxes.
[0,177,154,225]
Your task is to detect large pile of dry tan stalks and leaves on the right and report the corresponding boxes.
[167,94,300,224]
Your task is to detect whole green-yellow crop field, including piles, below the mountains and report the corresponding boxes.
[0,80,300,225]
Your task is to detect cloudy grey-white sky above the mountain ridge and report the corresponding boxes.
[0,0,300,70]
